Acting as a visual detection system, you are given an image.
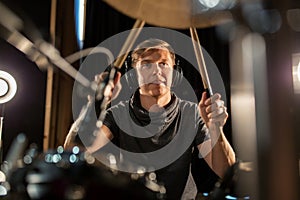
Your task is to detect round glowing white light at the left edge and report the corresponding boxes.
[0,70,17,104]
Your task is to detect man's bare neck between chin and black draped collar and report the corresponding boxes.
[140,90,171,112]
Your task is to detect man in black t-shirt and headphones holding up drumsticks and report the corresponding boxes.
[65,39,235,199]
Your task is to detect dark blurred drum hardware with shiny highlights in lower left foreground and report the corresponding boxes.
[1,145,165,200]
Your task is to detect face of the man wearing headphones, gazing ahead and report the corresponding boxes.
[136,49,174,95]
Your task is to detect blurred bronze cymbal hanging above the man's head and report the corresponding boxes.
[104,0,232,29]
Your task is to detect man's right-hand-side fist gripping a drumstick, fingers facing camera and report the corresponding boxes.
[198,92,228,127]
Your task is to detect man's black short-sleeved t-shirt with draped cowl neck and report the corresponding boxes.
[103,91,209,199]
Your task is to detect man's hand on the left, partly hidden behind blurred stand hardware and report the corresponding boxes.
[95,72,122,102]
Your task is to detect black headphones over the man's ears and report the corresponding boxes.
[124,55,183,90]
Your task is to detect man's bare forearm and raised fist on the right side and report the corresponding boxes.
[198,92,235,177]
